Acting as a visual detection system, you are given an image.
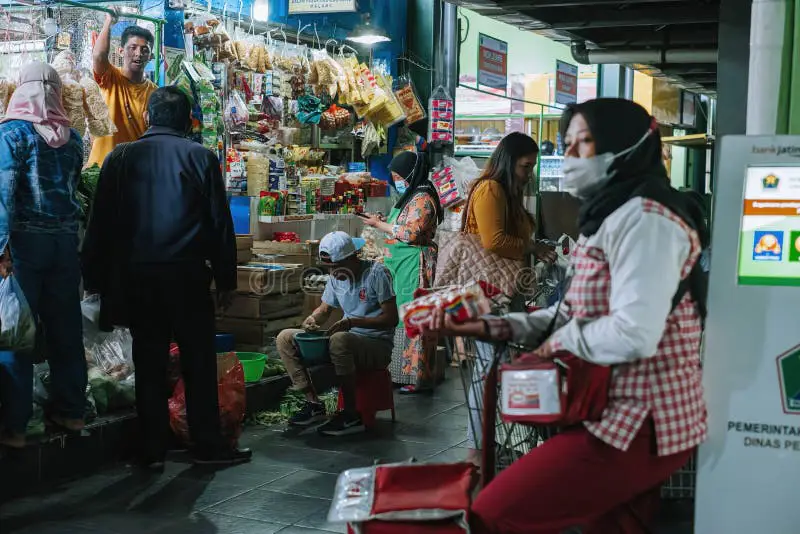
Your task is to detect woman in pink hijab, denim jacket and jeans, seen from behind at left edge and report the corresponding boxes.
[0,63,87,447]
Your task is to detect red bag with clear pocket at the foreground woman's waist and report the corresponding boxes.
[500,352,611,427]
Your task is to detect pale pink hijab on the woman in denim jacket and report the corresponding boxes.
[0,62,70,148]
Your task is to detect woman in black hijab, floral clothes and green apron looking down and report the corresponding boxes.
[364,152,444,393]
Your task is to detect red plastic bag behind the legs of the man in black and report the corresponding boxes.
[169,352,245,447]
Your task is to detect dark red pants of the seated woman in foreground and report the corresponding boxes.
[472,420,693,534]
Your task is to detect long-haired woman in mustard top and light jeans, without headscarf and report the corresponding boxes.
[463,132,556,464]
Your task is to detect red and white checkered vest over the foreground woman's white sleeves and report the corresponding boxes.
[566,199,707,456]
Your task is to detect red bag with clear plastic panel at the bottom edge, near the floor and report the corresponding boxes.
[328,462,478,534]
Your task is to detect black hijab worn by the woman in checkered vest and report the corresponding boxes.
[561,98,709,316]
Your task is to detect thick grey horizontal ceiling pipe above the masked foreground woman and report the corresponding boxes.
[570,41,718,65]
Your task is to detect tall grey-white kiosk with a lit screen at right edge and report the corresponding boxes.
[695,136,800,534]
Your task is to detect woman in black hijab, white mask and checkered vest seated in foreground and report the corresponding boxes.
[418,99,707,534]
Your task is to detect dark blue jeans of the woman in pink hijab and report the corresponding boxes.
[10,232,87,430]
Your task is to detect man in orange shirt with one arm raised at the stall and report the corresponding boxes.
[88,15,156,166]
